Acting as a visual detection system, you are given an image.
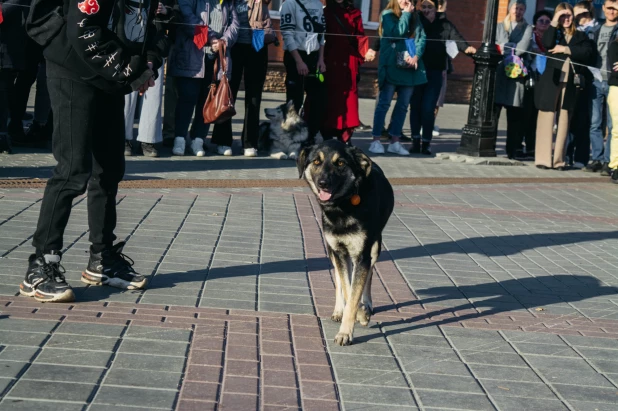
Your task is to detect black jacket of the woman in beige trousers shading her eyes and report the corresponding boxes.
[534,26,598,111]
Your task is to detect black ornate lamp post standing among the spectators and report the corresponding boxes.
[457,0,502,157]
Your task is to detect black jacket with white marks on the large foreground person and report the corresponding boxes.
[44,0,165,94]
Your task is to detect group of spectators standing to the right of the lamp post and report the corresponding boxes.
[495,0,618,183]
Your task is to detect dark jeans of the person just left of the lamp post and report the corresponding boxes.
[410,70,444,142]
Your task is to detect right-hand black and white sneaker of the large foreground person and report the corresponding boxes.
[82,241,147,290]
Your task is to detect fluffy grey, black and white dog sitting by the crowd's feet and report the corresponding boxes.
[258,101,322,160]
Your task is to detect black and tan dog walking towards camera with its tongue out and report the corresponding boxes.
[297,140,395,345]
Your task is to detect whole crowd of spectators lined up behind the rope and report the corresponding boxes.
[0,0,618,166]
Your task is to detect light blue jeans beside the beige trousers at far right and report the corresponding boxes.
[590,80,612,163]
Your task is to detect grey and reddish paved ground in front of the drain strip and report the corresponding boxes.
[0,183,618,411]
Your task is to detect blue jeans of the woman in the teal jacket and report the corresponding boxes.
[372,82,414,137]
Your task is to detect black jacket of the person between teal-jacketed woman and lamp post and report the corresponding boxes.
[419,13,470,71]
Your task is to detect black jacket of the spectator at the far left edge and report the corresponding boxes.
[0,0,30,70]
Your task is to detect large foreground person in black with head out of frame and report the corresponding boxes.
[20,0,165,302]
